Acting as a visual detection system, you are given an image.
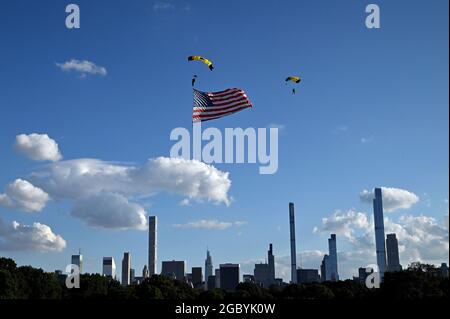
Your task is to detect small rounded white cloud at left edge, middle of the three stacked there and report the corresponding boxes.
[0,179,50,212]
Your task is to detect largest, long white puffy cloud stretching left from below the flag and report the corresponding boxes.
[30,157,231,205]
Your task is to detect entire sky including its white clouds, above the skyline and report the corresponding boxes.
[0,0,449,282]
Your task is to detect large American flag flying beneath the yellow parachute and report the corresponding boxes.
[192,88,253,122]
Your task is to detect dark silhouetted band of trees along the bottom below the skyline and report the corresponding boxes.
[0,258,449,301]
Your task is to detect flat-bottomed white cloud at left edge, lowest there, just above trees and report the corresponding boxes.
[0,219,66,252]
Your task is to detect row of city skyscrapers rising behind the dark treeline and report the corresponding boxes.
[55,194,447,290]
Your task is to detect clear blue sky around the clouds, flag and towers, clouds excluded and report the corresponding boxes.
[0,0,449,279]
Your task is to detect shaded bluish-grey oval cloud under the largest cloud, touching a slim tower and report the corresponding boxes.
[71,193,147,230]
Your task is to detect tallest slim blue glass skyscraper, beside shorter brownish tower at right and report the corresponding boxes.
[373,188,386,278]
